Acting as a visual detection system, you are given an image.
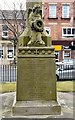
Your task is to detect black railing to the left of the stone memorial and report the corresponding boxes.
[0,64,17,82]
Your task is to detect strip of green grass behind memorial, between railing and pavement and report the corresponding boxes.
[0,81,75,93]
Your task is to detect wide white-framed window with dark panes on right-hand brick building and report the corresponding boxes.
[62,27,75,38]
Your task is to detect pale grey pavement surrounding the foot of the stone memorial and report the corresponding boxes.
[0,92,75,120]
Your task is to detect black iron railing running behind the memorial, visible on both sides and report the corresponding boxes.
[0,64,75,82]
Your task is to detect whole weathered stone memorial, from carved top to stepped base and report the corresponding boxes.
[12,1,61,116]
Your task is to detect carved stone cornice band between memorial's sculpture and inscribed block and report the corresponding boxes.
[18,47,54,57]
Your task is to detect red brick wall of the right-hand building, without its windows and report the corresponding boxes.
[43,0,75,61]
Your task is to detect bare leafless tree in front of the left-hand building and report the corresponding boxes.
[1,7,26,42]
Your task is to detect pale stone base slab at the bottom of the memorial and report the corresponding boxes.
[13,101,61,116]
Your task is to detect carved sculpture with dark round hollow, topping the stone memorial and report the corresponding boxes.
[18,1,52,47]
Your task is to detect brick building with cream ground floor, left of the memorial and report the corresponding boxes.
[0,10,26,64]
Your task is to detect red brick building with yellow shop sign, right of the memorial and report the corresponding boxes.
[42,0,75,61]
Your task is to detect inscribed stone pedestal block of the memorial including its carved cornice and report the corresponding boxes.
[17,47,56,101]
